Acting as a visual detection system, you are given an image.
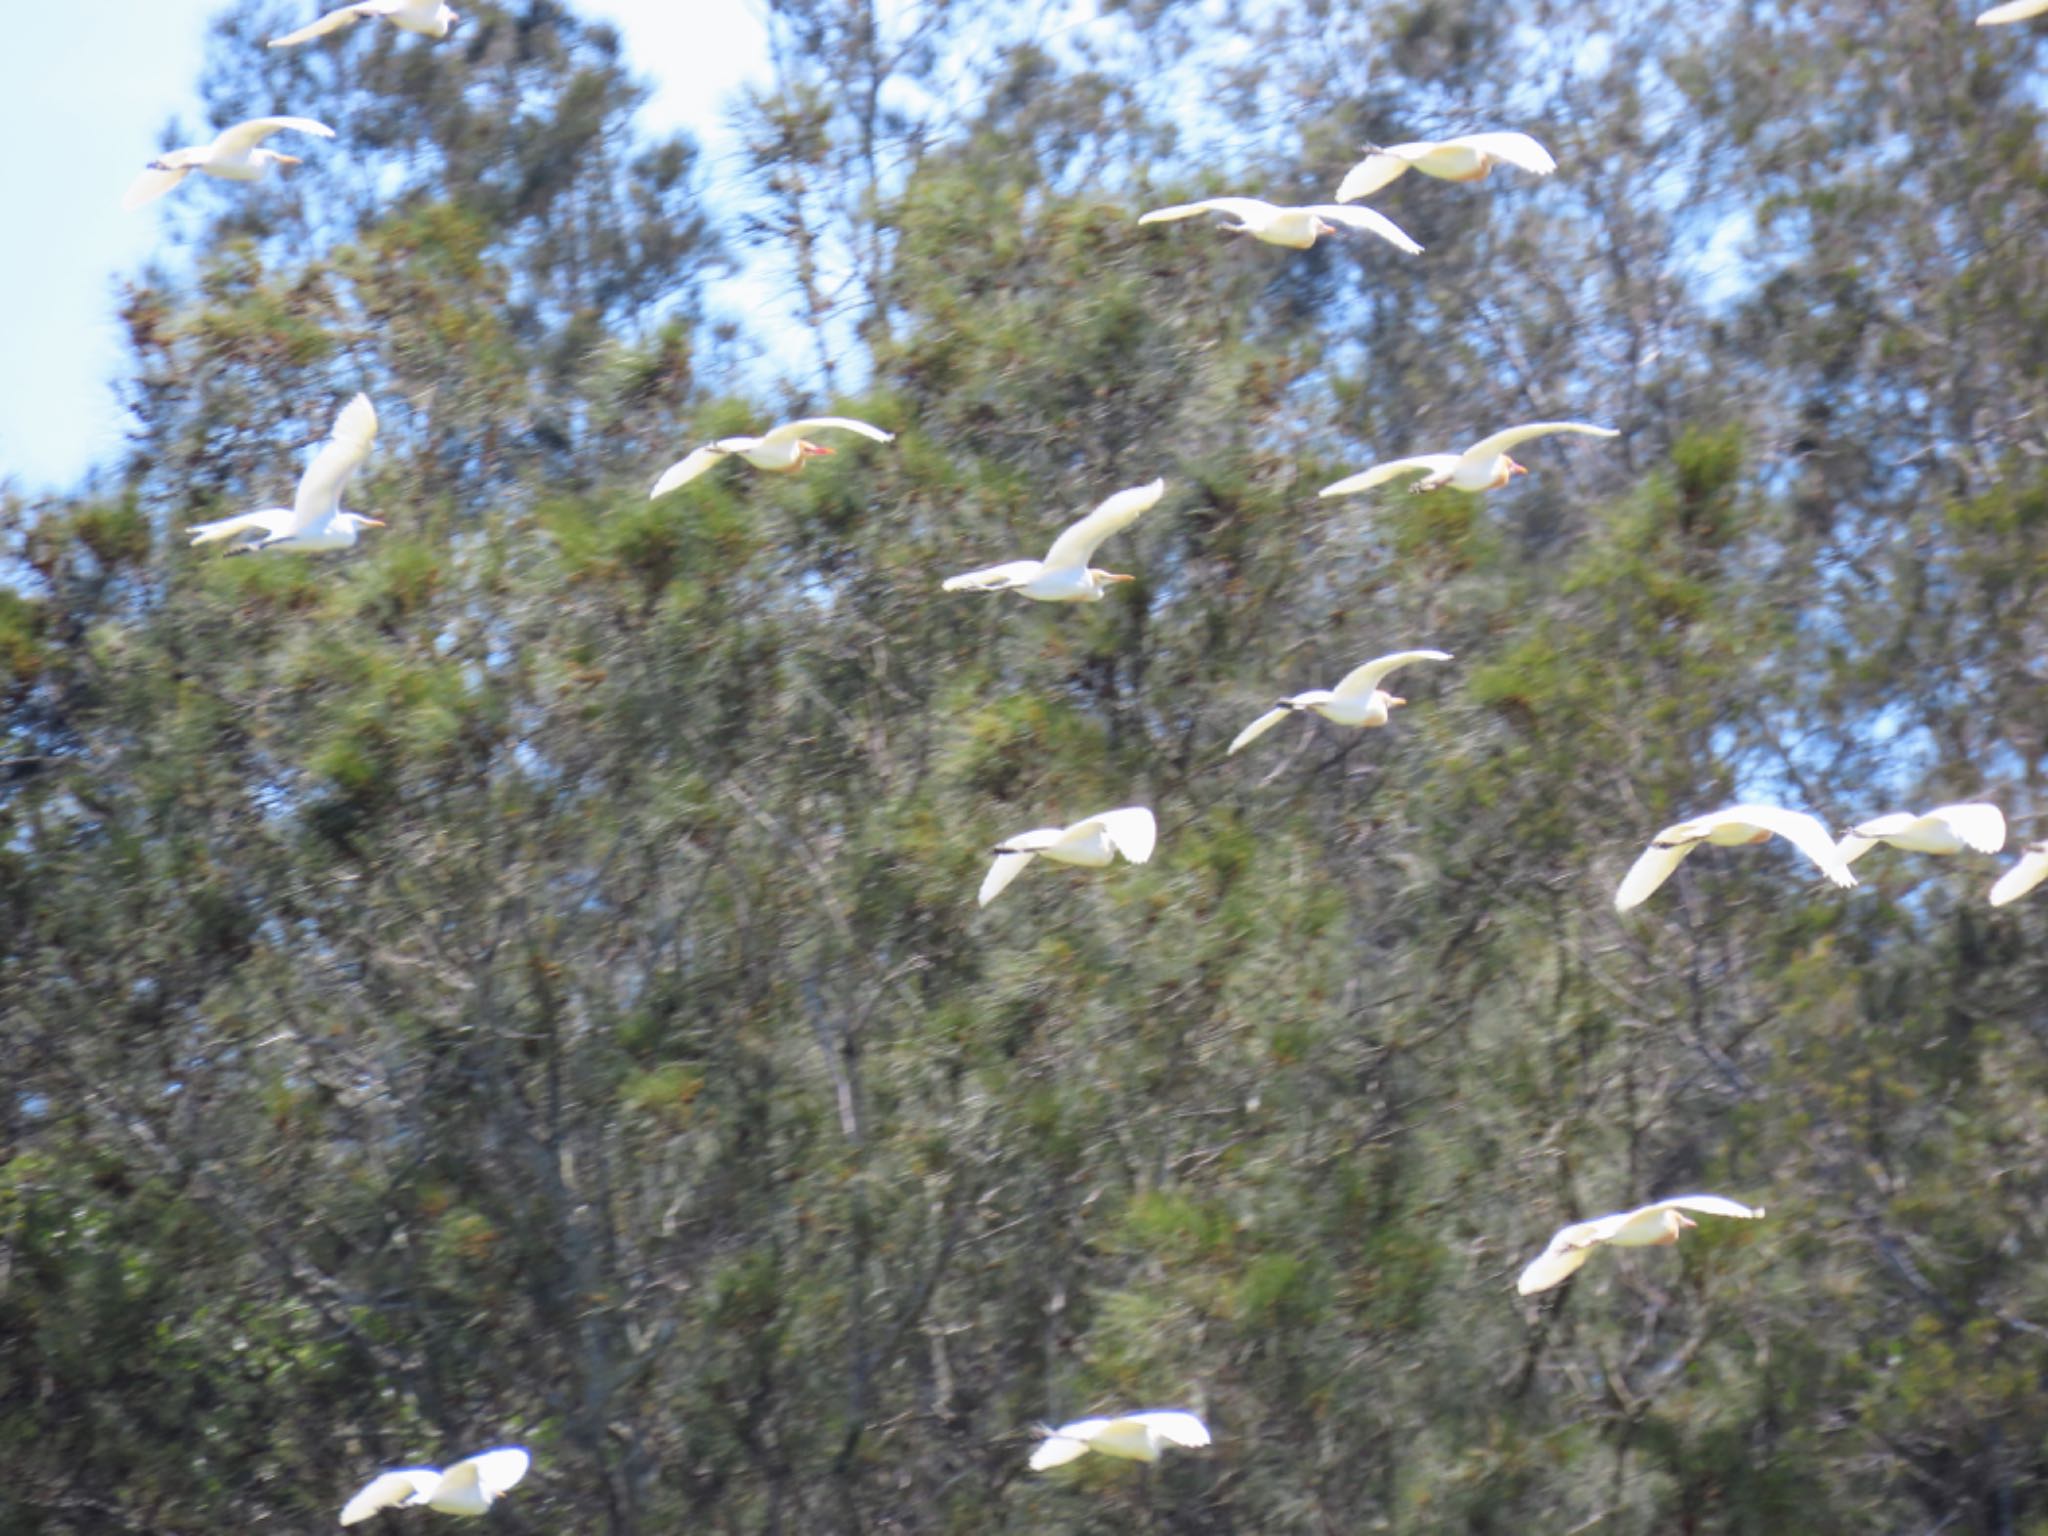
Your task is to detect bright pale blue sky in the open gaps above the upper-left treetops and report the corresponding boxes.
[0,0,766,494]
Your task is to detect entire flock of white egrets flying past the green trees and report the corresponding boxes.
[123,0,2048,1526]
